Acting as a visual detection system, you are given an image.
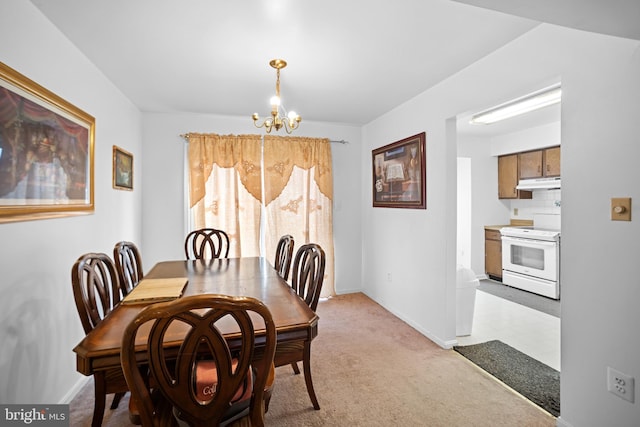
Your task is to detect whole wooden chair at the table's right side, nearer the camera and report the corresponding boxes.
[275,243,325,409]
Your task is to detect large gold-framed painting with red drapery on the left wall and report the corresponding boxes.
[0,62,95,222]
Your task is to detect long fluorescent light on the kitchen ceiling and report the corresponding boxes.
[469,83,562,125]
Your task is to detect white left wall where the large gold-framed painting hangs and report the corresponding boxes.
[0,0,142,403]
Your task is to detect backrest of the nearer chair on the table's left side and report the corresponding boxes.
[71,253,121,333]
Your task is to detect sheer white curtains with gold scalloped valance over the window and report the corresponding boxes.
[188,134,335,297]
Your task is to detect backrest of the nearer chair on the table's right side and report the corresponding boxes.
[291,243,325,311]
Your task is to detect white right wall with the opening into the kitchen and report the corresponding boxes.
[362,25,640,427]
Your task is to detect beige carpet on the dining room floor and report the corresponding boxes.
[70,294,556,427]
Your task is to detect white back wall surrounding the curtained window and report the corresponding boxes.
[142,113,362,293]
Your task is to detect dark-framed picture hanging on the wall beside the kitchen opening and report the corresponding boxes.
[371,132,427,209]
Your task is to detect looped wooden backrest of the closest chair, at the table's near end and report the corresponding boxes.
[121,294,276,426]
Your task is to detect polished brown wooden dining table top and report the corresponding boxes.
[73,257,318,375]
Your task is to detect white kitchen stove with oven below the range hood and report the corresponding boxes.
[500,215,560,299]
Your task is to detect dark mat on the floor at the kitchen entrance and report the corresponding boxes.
[453,340,560,417]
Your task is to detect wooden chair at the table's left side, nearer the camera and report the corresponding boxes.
[71,253,133,427]
